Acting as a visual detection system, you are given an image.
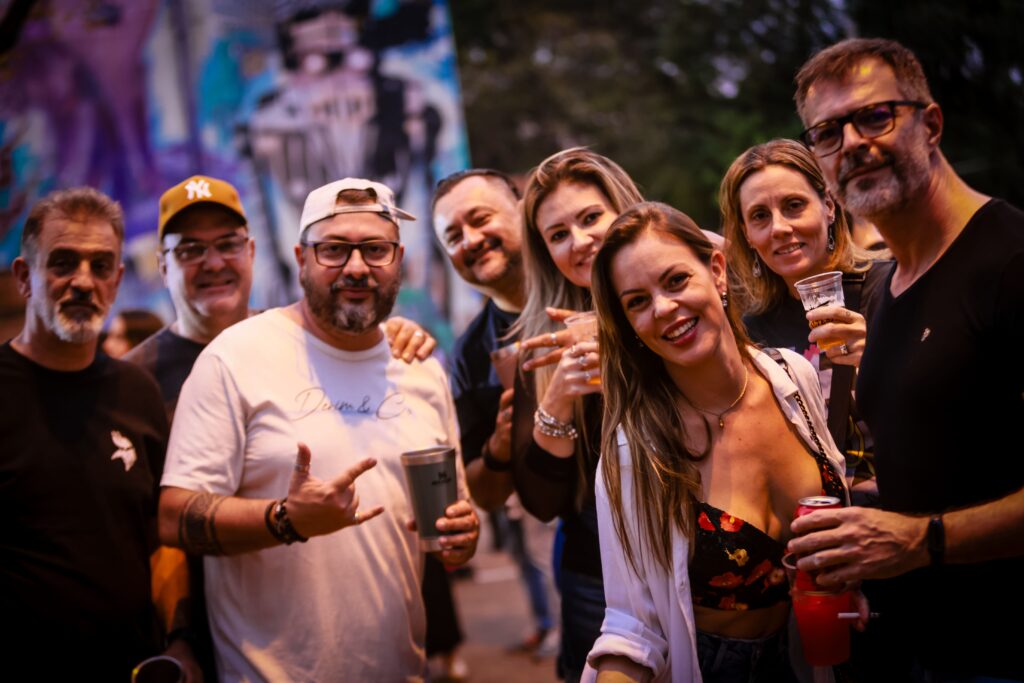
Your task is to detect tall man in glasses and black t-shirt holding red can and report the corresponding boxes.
[790,39,1024,681]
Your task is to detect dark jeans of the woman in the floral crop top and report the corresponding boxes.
[697,629,797,683]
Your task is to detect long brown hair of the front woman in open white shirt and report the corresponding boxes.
[593,202,750,571]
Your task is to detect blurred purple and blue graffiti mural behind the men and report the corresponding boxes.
[0,0,477,344]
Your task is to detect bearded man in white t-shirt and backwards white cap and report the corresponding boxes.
[160,178,479,681]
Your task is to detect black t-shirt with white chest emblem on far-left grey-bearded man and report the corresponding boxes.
[0,343,168,681]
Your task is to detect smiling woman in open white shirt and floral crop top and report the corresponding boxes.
[589,203,864,683]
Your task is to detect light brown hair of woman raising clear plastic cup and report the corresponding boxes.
[718,138,878,313]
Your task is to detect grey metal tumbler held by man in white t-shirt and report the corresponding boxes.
[401,445,459,552]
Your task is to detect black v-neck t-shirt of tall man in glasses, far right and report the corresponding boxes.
[857,200,1024,678]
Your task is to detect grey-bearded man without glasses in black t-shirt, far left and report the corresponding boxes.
[0,187,200,681]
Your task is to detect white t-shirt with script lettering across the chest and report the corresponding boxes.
[161,309,466,683]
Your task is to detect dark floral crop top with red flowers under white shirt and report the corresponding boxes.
[690,444,843,610]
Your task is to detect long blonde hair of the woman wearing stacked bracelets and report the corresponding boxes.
[509,147,643,504]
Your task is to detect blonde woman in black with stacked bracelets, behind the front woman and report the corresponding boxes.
[512,147,643,682]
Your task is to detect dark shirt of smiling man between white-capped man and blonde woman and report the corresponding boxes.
[452,299,518,465]
